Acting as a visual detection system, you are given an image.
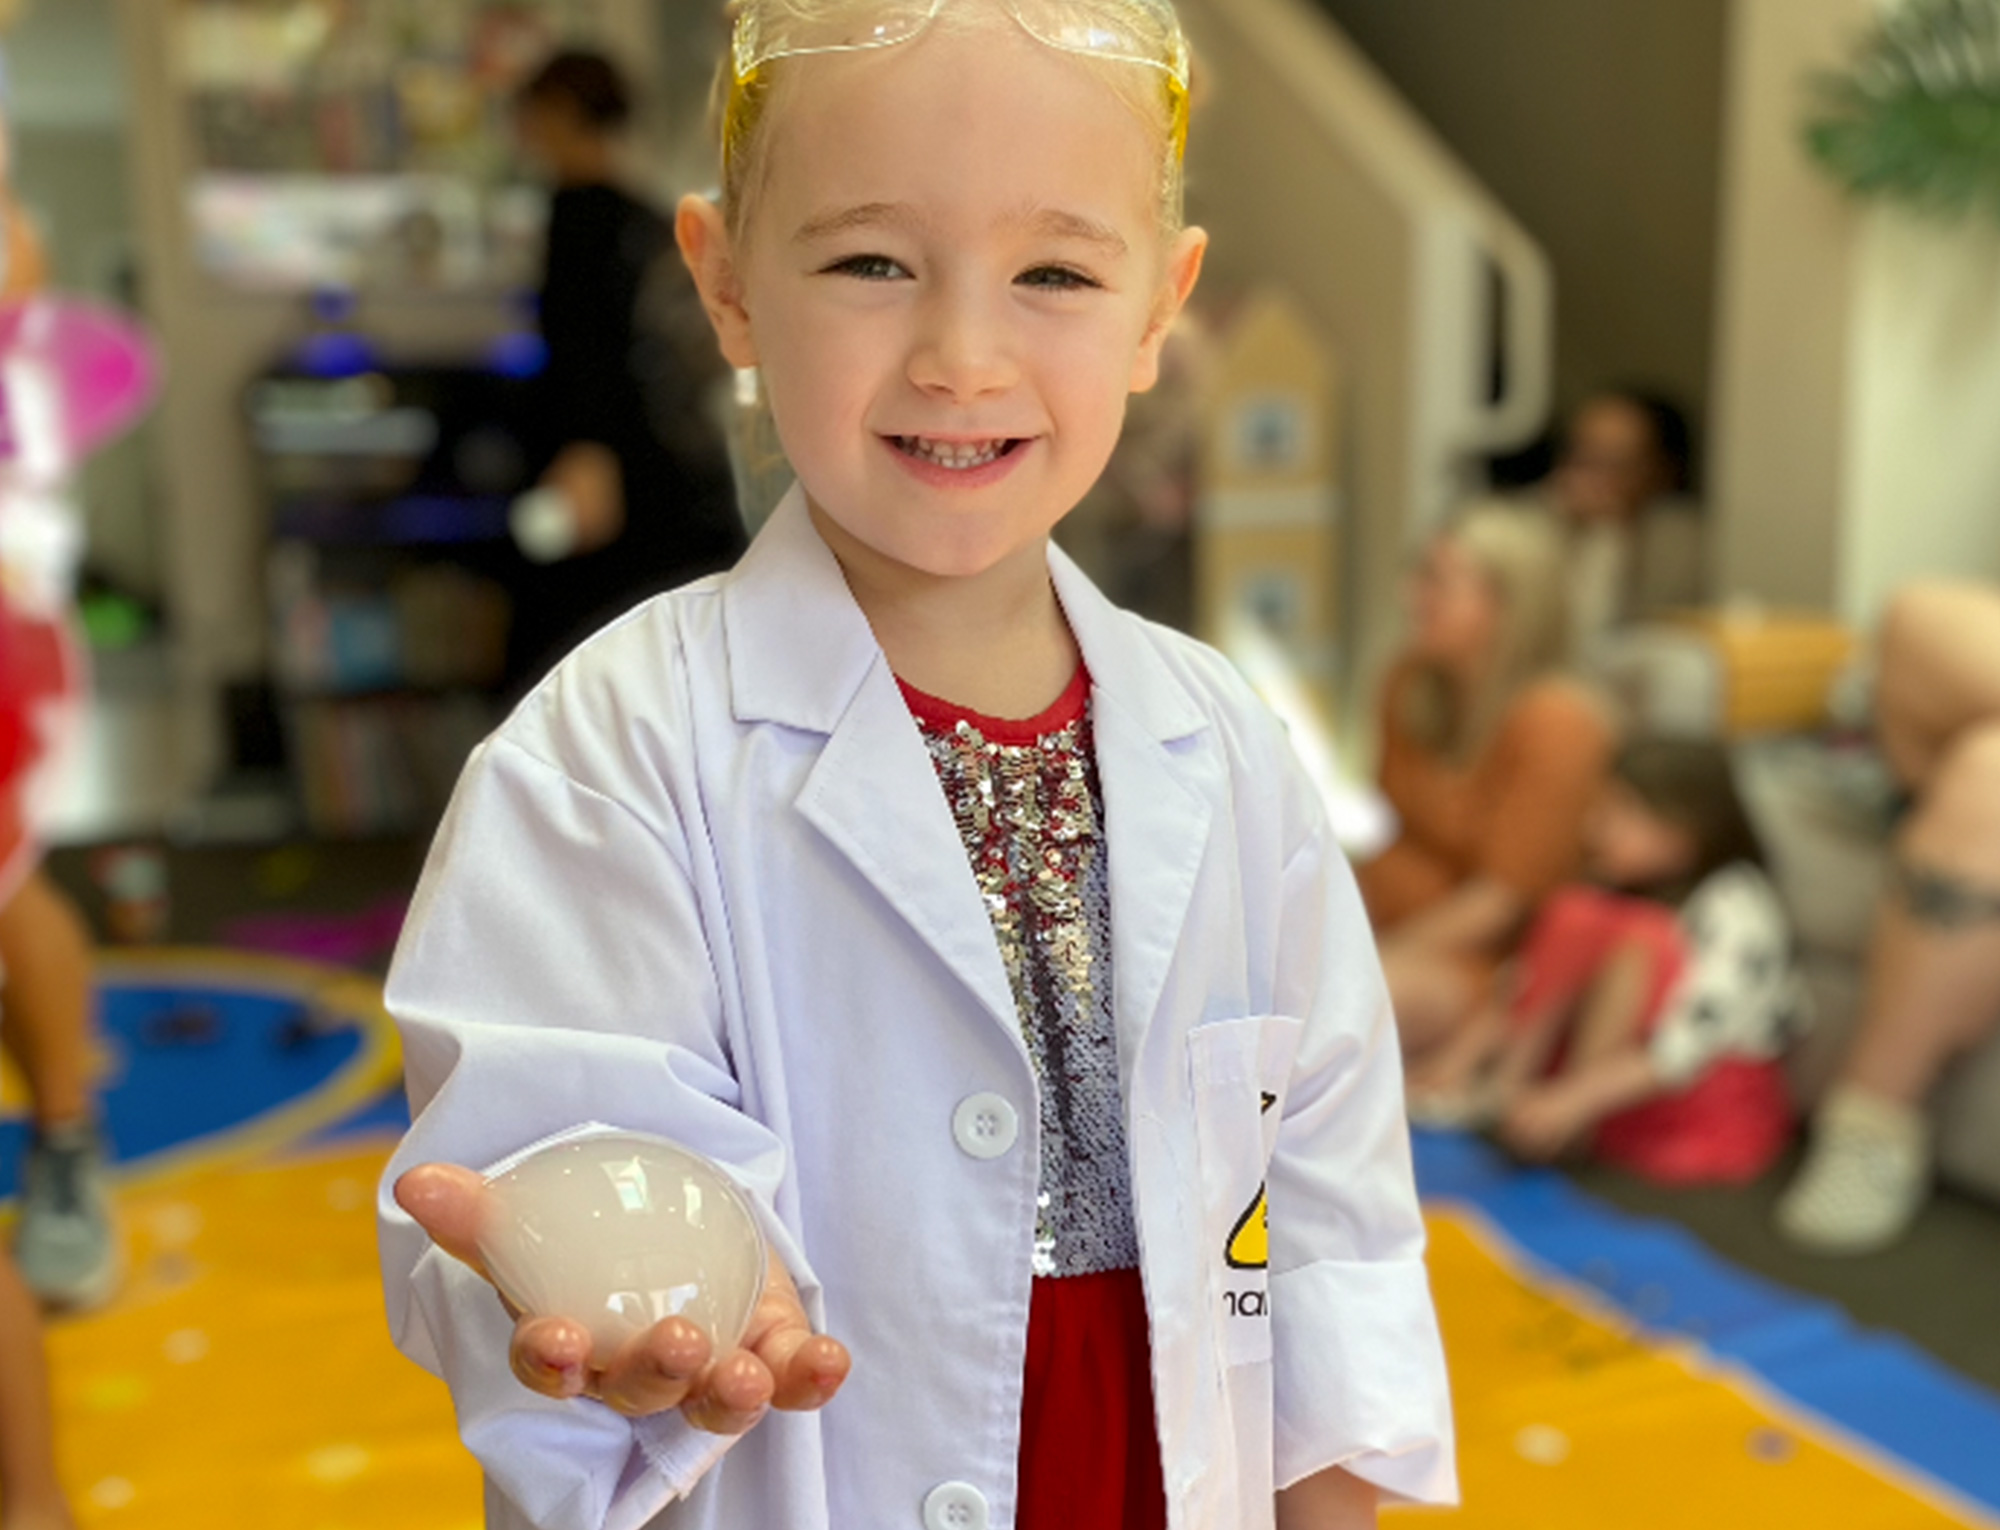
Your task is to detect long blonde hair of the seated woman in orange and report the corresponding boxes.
[1402,500,1570,762]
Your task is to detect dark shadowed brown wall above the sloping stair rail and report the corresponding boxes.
[1320,0,1728,432]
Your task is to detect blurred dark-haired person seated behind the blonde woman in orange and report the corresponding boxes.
[1540,390,1708,656]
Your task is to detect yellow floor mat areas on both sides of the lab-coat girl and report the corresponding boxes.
[19,1142,1984,1530]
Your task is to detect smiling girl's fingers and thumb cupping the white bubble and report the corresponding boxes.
[396,1164,852,1434]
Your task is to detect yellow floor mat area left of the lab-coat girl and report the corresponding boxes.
[48,1142,480,1530]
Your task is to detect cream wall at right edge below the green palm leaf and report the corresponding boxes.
[1712,0,2000,626]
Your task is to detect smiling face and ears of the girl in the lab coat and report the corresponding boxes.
[680,26,1204,576]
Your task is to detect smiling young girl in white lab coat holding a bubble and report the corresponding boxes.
[382,0,1454,1530]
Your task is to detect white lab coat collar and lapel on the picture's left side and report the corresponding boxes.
[722,488,1020,1044]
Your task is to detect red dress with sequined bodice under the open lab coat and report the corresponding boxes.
[904,668,1166,1530]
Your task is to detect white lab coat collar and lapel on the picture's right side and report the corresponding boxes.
[1050,550,1216,1070]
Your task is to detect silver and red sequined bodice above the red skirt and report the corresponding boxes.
[904,668,1138,1276]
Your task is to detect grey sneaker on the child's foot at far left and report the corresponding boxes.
[14,1122,118,1308]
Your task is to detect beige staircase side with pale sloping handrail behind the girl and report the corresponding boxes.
[1182,0,1552,716]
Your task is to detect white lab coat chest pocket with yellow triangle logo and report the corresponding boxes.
[1188,1014,1304,1366]
